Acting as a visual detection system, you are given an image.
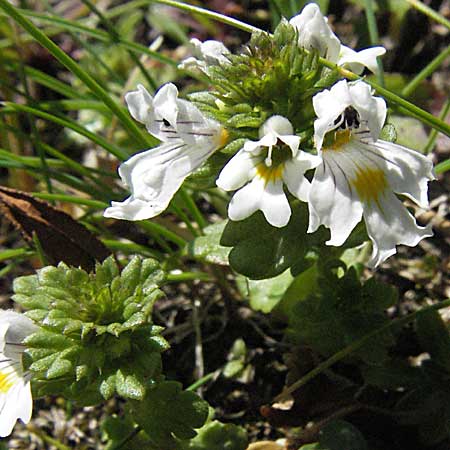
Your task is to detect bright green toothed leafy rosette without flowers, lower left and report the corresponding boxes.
[14,258,168,404]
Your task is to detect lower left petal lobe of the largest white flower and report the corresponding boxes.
[308,151,363,246]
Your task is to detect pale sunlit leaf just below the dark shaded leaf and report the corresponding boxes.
[236,270,294,313]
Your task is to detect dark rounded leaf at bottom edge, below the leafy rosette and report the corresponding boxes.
[132,381,208,450]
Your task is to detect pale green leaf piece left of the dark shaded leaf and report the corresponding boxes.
[188,221,230,266]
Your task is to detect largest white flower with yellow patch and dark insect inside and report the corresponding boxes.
[308,80,434,267]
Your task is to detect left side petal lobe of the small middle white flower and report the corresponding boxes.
[216,149,261,191]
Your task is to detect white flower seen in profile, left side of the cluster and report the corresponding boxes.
[104,83,228,220]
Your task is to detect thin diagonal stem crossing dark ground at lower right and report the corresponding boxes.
[274,299,450,402]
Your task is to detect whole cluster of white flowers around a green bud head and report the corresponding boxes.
[105,4,433,267]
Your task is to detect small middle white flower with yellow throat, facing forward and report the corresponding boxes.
[216,116,320,227]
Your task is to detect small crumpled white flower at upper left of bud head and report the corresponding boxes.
[178,38,230,74]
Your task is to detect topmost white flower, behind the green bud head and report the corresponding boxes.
[289,3,386,74]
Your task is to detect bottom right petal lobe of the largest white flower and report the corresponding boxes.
[364,191,433,267]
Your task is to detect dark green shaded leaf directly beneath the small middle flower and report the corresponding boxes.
[220,202,326,279]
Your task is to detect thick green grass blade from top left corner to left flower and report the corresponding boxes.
[0,0,149,146]
